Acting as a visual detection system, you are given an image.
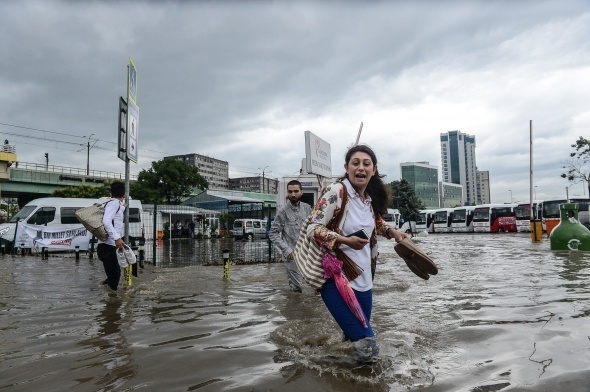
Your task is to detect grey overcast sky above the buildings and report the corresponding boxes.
[0,0,590,203]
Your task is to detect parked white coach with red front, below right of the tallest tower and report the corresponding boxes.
[473,204,516,233]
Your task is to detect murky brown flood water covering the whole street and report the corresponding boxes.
[0,234,590,392]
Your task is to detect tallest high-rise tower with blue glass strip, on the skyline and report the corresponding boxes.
[440,131,478,205]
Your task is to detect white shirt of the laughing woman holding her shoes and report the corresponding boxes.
[340,179,375,291]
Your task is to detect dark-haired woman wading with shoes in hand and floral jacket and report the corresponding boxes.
[307,145,408,361]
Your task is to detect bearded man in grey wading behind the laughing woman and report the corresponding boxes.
[268,180,311,293]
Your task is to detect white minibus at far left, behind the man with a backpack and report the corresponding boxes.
[0,197,143,251]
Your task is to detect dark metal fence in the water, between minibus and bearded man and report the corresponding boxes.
[141,205,280,268]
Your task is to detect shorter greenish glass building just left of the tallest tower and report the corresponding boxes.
[400,162,439,208]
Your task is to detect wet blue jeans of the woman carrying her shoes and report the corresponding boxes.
[320,279,375,342]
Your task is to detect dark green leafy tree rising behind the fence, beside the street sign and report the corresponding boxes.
[130,158,209,204]
